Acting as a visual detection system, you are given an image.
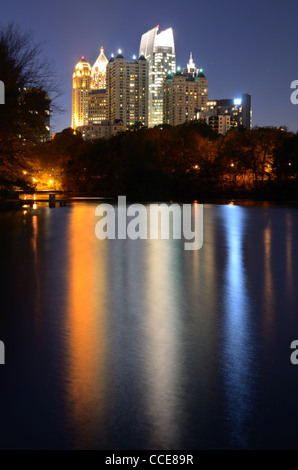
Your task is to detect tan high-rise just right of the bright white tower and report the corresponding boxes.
[163,69,208,126]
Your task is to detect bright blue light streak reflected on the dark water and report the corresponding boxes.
[222,206,254,447]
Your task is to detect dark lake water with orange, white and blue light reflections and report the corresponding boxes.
[0,202,298,450]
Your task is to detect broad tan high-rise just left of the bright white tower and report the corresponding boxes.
[107,51,148,129]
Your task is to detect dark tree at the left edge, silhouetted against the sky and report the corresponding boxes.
[0,23,59,189]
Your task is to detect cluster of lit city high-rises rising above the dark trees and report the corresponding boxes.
[71,38,252,139]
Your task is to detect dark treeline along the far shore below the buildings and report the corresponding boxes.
[29,121,298,200]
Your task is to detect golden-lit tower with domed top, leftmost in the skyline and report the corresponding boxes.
[71,57,91,129]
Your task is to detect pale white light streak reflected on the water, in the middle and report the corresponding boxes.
[144,240,182,449]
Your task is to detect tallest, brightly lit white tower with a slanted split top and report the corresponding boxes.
[139,26,176,127]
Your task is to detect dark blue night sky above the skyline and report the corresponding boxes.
[0,0,298,132]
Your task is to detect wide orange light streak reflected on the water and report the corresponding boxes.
[66,206,107,448]
